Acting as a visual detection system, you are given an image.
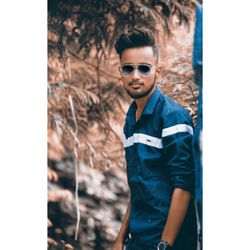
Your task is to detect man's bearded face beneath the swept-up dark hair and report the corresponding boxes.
[120,46,160,99]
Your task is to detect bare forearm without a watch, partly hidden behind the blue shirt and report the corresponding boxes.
[112,201,130,250]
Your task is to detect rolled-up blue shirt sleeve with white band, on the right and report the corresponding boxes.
[162,111,194,193]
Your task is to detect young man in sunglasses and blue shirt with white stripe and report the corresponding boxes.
[113,28,197,250]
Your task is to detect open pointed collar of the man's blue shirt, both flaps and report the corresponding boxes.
[127,87,161,117]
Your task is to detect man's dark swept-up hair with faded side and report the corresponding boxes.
[115,28,159,62]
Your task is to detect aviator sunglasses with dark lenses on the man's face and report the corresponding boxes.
[120,63,153,77]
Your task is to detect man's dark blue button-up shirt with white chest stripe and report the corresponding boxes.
[124,88,196,249]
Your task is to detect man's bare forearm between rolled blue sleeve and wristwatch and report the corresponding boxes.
[161,188,191,246]
